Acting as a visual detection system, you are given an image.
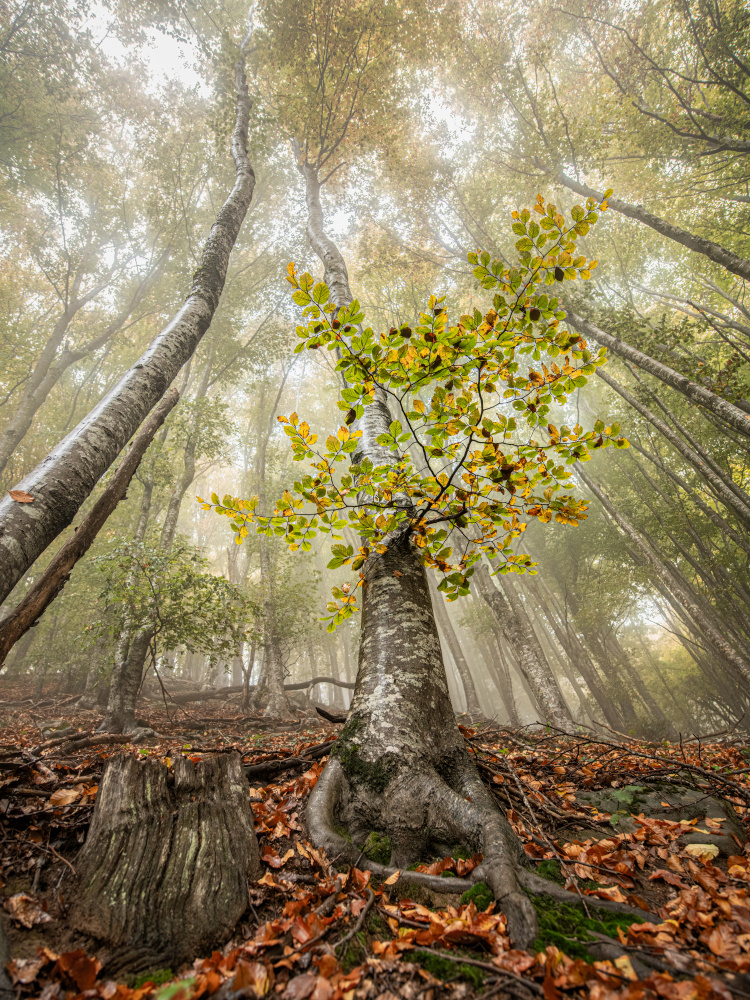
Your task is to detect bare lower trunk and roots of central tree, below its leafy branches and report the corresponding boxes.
[307,532,536,946]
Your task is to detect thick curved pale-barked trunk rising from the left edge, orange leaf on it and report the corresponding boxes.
[0,58,255,601]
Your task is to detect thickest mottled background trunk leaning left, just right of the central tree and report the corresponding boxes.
[472,563,574,731]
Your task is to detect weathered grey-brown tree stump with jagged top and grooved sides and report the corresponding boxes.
[71,753,260,971]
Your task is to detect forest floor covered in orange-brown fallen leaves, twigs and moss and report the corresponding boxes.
[0,681,750,1000]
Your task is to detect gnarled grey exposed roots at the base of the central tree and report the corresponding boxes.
[307,757,643,948]
